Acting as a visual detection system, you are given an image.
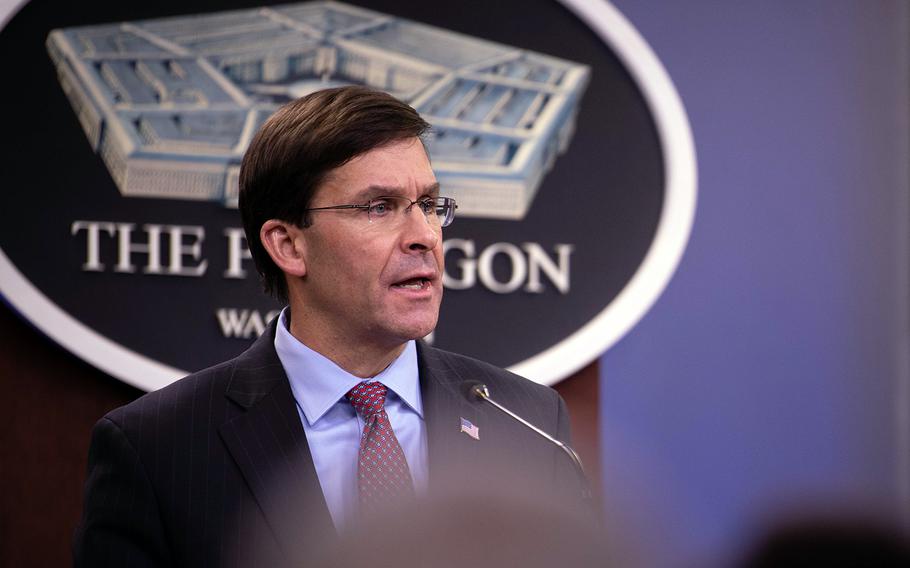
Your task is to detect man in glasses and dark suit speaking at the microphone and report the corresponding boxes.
[74,87,578,566]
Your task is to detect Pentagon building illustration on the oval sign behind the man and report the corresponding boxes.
[47,2,589,220]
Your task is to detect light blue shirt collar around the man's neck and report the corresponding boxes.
[275,308,423,425]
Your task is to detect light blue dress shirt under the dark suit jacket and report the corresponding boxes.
[275,308,427,529]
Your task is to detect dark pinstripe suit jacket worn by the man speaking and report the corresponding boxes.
[74,323,577,567]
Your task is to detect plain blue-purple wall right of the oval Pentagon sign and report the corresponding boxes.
[601,0,910,566]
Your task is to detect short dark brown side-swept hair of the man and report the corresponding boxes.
[239,86,430,301]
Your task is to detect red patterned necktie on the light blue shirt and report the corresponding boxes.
[347,381,414,513]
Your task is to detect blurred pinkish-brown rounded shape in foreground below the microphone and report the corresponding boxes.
[317,493,633,568]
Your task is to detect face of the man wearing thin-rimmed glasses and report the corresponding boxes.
[295,138,443,347]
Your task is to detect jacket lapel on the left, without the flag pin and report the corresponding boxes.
[219,321,335,558]
